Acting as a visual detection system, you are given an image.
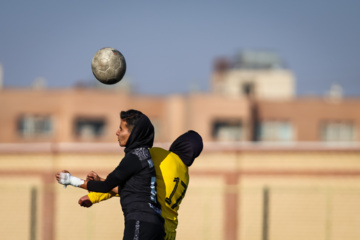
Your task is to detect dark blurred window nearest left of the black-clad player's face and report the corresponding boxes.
[74,117,106,139]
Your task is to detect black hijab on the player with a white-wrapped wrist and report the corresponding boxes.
[124,114,154,153]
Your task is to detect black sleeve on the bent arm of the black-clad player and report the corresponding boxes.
[87,154,142,193]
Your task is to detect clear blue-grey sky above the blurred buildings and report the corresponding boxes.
[0,0,360,96]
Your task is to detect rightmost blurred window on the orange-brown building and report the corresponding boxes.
[320,122,356,142]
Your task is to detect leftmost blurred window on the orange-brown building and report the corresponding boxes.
[17,115,53,137]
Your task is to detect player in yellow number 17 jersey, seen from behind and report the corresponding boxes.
[79,131,203,240]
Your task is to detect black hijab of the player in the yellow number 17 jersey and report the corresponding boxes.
[169,130,203,167]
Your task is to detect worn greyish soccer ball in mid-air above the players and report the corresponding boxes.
[91,47,126,84]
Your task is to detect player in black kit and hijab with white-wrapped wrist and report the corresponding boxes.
[56,110,165,240]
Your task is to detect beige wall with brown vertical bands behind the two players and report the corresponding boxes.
[0,143,360,240]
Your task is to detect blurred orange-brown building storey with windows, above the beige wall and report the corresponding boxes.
[0,89,360,143]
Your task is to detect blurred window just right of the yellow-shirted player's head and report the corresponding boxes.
[212,120,243,141]
